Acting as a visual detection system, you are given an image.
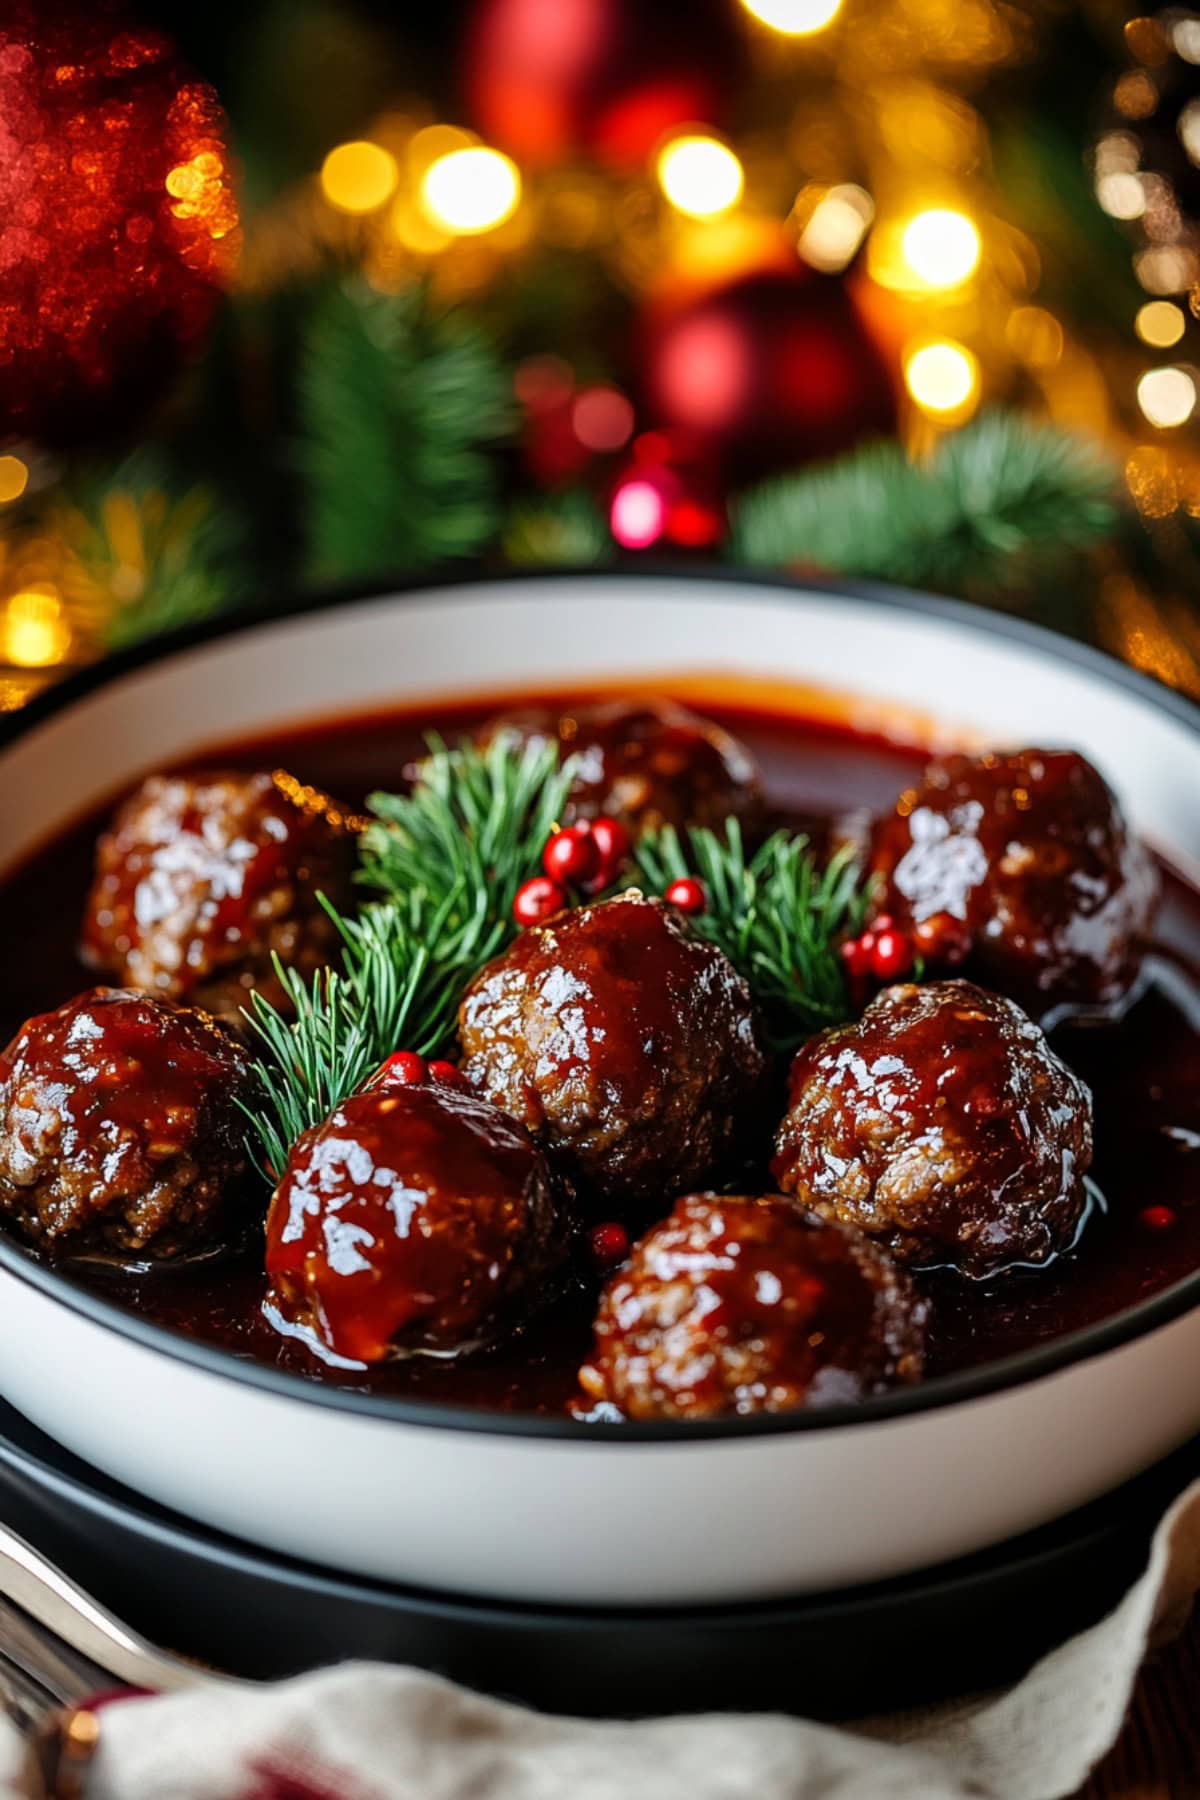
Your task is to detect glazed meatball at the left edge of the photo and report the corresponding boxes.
[0,988,254,1258]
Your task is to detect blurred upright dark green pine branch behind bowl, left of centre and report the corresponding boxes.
[299,283,516,580]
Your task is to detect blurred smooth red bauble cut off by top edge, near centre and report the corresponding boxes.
[462,0,741,166]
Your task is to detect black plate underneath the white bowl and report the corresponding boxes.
[0,1402,1200,1719]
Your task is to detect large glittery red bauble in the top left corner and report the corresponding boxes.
[0,0,237,445]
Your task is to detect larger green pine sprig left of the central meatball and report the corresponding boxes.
[246,733,574,1179]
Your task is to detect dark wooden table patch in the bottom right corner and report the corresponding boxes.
[1078,1607,1200,1800]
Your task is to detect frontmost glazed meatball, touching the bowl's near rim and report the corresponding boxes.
[579,1193,925,1418]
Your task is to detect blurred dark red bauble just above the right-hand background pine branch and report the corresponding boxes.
[640,263,898,481]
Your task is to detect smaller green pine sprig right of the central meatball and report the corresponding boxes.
[637,819,869,1051]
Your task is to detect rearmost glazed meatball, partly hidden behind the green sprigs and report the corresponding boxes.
[480,700,763,832]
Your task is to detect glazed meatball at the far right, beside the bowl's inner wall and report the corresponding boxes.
[871,751,1159,1017]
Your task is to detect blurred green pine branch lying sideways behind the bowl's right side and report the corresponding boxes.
[730,412,1117,589]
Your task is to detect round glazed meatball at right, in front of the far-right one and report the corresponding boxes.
[772,981,1092,1276]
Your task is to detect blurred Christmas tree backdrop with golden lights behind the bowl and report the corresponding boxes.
[0,0,1200,706]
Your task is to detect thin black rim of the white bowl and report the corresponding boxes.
[0,560,1200,1447]
